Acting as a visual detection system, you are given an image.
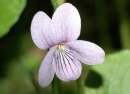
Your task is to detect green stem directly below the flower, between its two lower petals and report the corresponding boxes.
[52,76,60,94]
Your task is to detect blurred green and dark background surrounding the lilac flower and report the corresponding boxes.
[0,0,130,94]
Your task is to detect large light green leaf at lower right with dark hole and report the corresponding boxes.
[85,50,130,94]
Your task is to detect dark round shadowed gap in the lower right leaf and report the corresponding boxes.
[85,70,103,88]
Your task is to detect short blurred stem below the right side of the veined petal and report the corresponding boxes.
[77,76,84,94]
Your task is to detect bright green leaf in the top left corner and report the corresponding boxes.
[0,0,26,38]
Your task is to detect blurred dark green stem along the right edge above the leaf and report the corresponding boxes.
[116,0,130,49]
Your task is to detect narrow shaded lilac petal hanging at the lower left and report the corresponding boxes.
[39,47,56,87]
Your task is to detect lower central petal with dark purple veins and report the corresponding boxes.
[53,46,81,82]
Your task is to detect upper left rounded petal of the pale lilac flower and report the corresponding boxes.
[31,11,58,50]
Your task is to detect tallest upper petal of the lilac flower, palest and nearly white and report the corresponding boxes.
[52,3,81,43]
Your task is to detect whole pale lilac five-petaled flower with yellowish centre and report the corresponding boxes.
[31,3,105,87]
